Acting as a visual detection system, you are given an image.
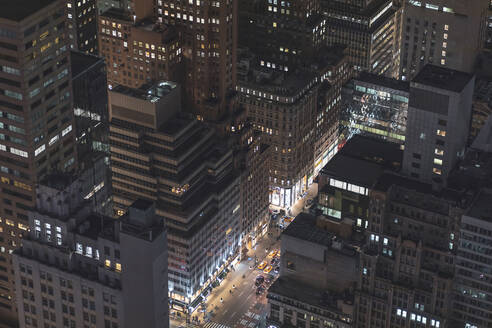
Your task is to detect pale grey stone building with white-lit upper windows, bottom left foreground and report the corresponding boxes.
[13,175,169,328]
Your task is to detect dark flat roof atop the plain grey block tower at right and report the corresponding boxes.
[412,64,473,92]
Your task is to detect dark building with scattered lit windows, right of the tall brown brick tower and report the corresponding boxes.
[239,0,326,72]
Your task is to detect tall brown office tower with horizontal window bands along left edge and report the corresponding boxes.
[0,0,76,322]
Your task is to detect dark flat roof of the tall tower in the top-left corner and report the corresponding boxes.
[0,0,56,22]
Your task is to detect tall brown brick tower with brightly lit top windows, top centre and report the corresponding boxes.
[156,0,238,120]
